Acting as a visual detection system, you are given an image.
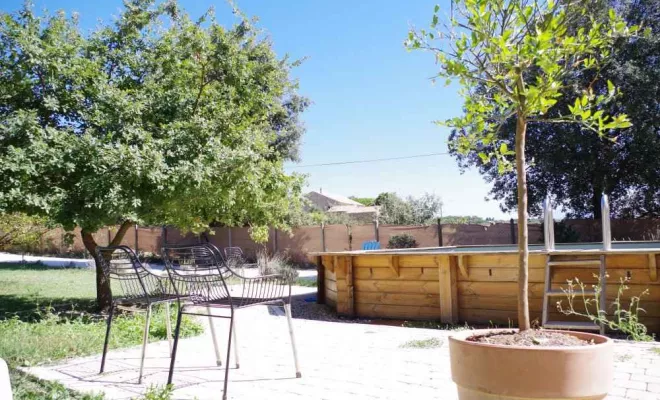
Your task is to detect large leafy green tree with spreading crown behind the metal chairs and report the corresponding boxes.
[0,0,307,308]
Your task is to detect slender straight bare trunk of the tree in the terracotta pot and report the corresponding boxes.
[516,114,530,331]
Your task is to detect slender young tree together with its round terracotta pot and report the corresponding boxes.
[406,0,636,400]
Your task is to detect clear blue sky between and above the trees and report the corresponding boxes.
[2,0,510,218]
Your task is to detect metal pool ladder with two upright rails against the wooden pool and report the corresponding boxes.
[542,195,612,334]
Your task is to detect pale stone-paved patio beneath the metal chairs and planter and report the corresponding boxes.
[27,307,660,400]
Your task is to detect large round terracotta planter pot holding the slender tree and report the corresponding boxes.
[449,329,614,400]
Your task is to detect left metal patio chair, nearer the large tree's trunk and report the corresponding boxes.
[96,246,179,383]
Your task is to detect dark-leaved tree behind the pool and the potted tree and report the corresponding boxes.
[450,0,660,219]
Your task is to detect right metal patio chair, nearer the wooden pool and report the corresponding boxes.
[162,243,302,399]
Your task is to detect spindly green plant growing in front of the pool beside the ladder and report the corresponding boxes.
[557,275,653,342]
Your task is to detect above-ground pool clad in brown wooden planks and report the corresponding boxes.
[314,242,660,333]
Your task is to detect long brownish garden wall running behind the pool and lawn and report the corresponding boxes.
[6,220,660,261]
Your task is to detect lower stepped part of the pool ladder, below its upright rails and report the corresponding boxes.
[542,254,606,334]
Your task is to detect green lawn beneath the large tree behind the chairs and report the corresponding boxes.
[0,264,202,400]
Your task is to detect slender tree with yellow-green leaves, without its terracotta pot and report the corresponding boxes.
[407,0,630,330]
